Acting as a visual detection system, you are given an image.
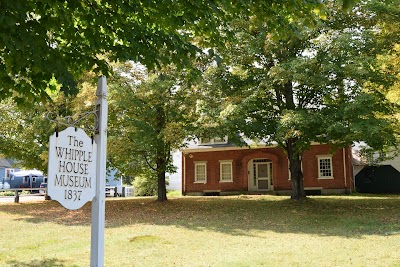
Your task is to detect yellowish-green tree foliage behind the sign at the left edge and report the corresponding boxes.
[0,73,96,173]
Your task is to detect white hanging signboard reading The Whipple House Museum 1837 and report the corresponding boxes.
[47,127,97,210]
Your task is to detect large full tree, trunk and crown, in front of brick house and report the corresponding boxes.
[200,2,396,200]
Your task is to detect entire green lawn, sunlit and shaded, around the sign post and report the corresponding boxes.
[0,195,400,267]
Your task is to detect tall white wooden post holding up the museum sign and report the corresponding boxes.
[90,76,108,267]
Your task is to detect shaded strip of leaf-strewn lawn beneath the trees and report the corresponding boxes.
[0,195,400,238]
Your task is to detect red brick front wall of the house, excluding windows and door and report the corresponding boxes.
[182,145,352,193]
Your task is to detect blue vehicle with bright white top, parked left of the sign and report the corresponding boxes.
[7,170,47,188]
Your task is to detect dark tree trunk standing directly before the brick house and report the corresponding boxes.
[286,138,306,200]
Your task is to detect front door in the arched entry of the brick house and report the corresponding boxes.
[249,159,272,191]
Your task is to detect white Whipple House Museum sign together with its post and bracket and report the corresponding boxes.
[48,76,108,267]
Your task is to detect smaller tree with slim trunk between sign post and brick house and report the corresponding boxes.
[109,63,196,201]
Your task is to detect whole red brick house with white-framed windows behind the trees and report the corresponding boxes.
[182,139,353,195]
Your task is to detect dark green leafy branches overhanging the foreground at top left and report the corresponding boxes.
[0,0,354,102]
